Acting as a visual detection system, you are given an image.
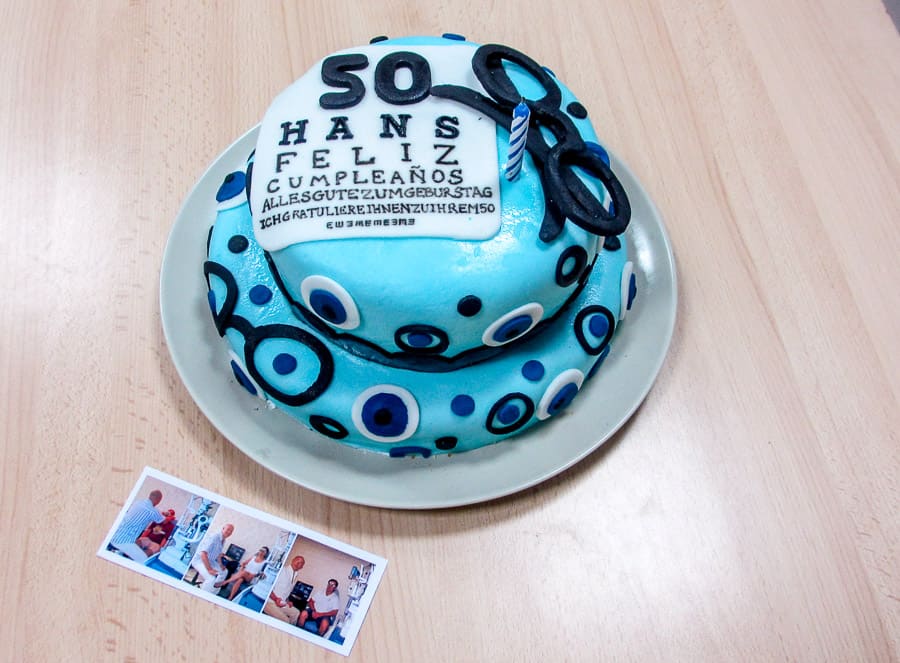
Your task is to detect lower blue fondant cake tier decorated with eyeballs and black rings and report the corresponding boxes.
[204,179,636,457]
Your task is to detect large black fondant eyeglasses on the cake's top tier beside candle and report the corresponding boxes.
[431,44,631,243]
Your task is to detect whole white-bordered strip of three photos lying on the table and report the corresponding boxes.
[97,468,387,656]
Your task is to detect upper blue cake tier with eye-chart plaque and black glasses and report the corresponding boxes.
[248,37,630,371]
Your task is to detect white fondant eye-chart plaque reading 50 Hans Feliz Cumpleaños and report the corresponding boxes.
[251,44,500,251]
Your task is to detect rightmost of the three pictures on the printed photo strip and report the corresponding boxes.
[263,535,375,644]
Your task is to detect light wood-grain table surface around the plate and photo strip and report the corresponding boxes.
[0,0,900,662]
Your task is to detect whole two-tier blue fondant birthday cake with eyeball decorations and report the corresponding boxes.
[203,35,636,457]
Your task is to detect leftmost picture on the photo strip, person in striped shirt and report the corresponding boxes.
[106,476,219,579]
